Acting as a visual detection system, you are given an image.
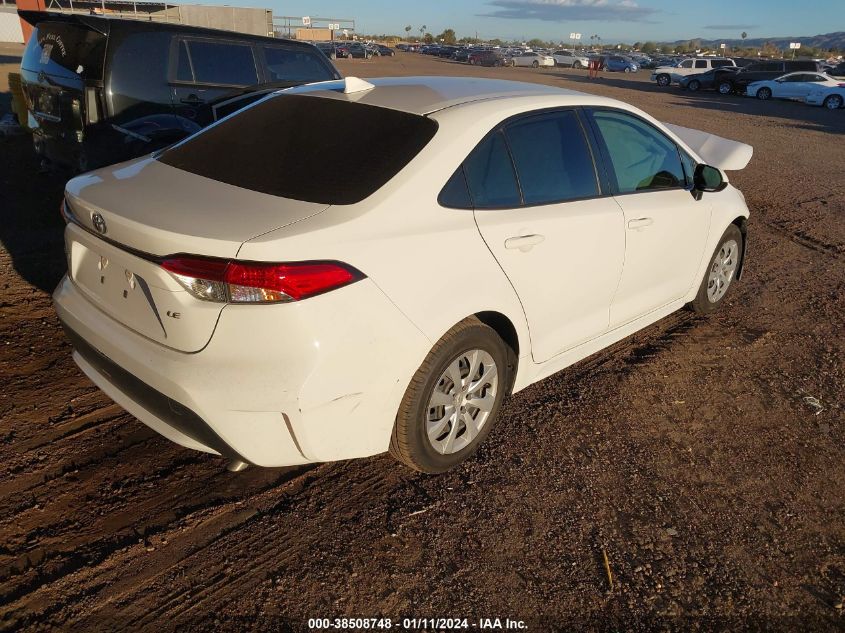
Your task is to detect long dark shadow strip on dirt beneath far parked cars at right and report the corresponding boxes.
[550,72,845,134]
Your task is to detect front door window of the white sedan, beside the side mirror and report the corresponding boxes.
[591,110,686,193]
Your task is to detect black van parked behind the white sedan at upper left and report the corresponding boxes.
[19,11,340,171]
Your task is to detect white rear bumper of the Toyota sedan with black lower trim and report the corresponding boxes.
[53,277,430,466]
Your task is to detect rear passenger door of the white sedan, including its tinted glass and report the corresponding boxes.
[464,109,625,363]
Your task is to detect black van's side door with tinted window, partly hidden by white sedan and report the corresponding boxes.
[171,37,261,127]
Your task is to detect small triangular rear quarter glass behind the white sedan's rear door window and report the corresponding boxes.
[464,132,522,209]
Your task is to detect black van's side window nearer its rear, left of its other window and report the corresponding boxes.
[176,40,258,86]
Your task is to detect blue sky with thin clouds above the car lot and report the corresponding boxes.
[198,0,845,44]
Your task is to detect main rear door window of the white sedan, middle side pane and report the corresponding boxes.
[506,111,599,204]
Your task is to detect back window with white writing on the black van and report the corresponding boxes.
[21,22,106,79]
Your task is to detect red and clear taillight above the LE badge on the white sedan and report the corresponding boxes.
[161,257,364,303]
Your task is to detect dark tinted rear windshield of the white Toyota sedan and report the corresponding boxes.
[159,95,437,204]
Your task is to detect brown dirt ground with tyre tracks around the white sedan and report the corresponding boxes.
[0,43,845,631]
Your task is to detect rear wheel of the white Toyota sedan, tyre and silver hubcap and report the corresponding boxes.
[390,317,516,474]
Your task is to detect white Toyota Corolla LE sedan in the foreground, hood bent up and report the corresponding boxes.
[54,77,752,473]
